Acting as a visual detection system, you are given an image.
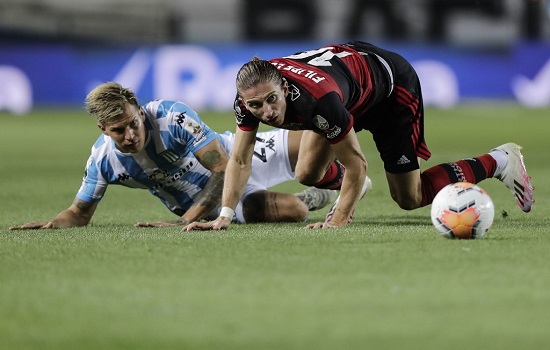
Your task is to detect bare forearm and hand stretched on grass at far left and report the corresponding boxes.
[10,198,97,230]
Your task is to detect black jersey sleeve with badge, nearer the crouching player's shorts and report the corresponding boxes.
[312,92,353,144]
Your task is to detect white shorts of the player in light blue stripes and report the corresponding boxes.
[218,129,295,223]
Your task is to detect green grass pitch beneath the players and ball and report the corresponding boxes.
[0,104,550,350]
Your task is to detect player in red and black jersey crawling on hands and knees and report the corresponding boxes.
[187,41,533,230]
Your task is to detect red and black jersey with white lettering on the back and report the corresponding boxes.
[235,44,388,143]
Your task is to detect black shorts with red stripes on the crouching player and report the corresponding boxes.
[350,42,431,174]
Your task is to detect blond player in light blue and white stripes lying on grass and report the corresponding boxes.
[11,82,335,229]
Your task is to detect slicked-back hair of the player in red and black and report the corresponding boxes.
[237,56,284,95]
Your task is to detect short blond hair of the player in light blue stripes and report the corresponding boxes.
[86,82,139,126]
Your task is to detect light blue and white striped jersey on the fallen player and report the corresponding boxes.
[76,100,225,216]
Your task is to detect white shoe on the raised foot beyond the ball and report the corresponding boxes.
[491,143,535,213]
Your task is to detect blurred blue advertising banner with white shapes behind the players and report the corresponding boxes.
[0,42,550,113]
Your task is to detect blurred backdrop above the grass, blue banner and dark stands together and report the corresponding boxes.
[0,0,550,114]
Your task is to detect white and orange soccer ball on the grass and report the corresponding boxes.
[431,182,495,239]
